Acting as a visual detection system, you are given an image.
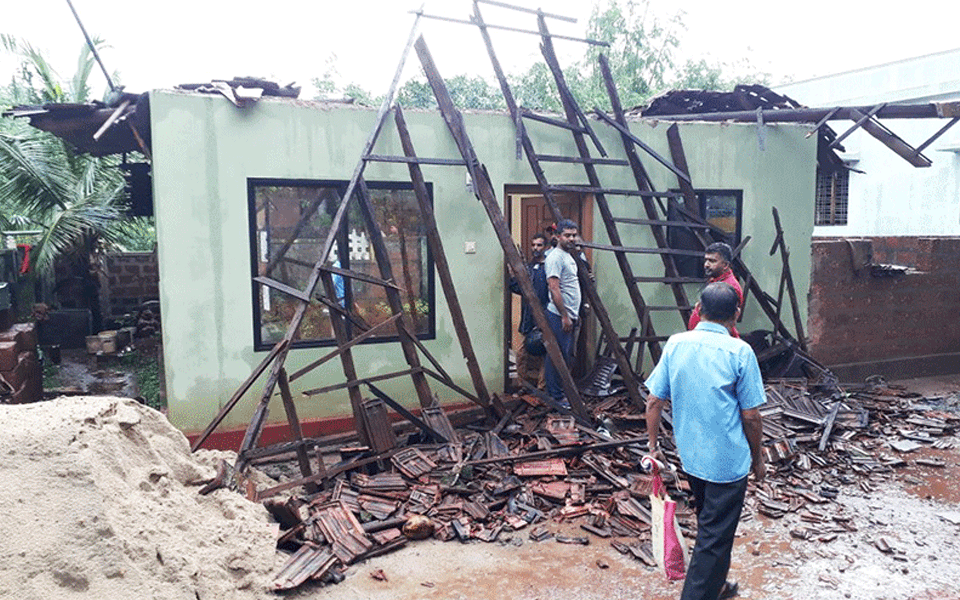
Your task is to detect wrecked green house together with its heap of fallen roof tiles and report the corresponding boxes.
[1,5,960,590]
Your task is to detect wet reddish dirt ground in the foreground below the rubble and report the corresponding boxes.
[278,375,960,600]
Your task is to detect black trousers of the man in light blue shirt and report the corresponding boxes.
[680,476,747,600]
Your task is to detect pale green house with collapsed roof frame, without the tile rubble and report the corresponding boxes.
[5,9,944,458]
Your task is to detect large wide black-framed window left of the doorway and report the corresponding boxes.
[247,179,435,350]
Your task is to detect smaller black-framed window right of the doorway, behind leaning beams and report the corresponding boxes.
[667,190,743,277]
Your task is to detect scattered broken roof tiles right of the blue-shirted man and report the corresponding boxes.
[747,380,960,528]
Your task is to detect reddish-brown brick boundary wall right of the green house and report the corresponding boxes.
[809,237,960,376]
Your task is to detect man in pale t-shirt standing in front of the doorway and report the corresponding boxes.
[544,219,580,407]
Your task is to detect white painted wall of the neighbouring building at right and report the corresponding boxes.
[777,48,960,237]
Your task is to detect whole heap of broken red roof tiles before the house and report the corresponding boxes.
[251,380,960,590]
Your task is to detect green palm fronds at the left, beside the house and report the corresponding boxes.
[0,36,155,273]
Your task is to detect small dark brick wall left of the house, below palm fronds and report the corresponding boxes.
[100,252,160,318]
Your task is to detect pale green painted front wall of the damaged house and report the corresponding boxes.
[150,91,816,431]
